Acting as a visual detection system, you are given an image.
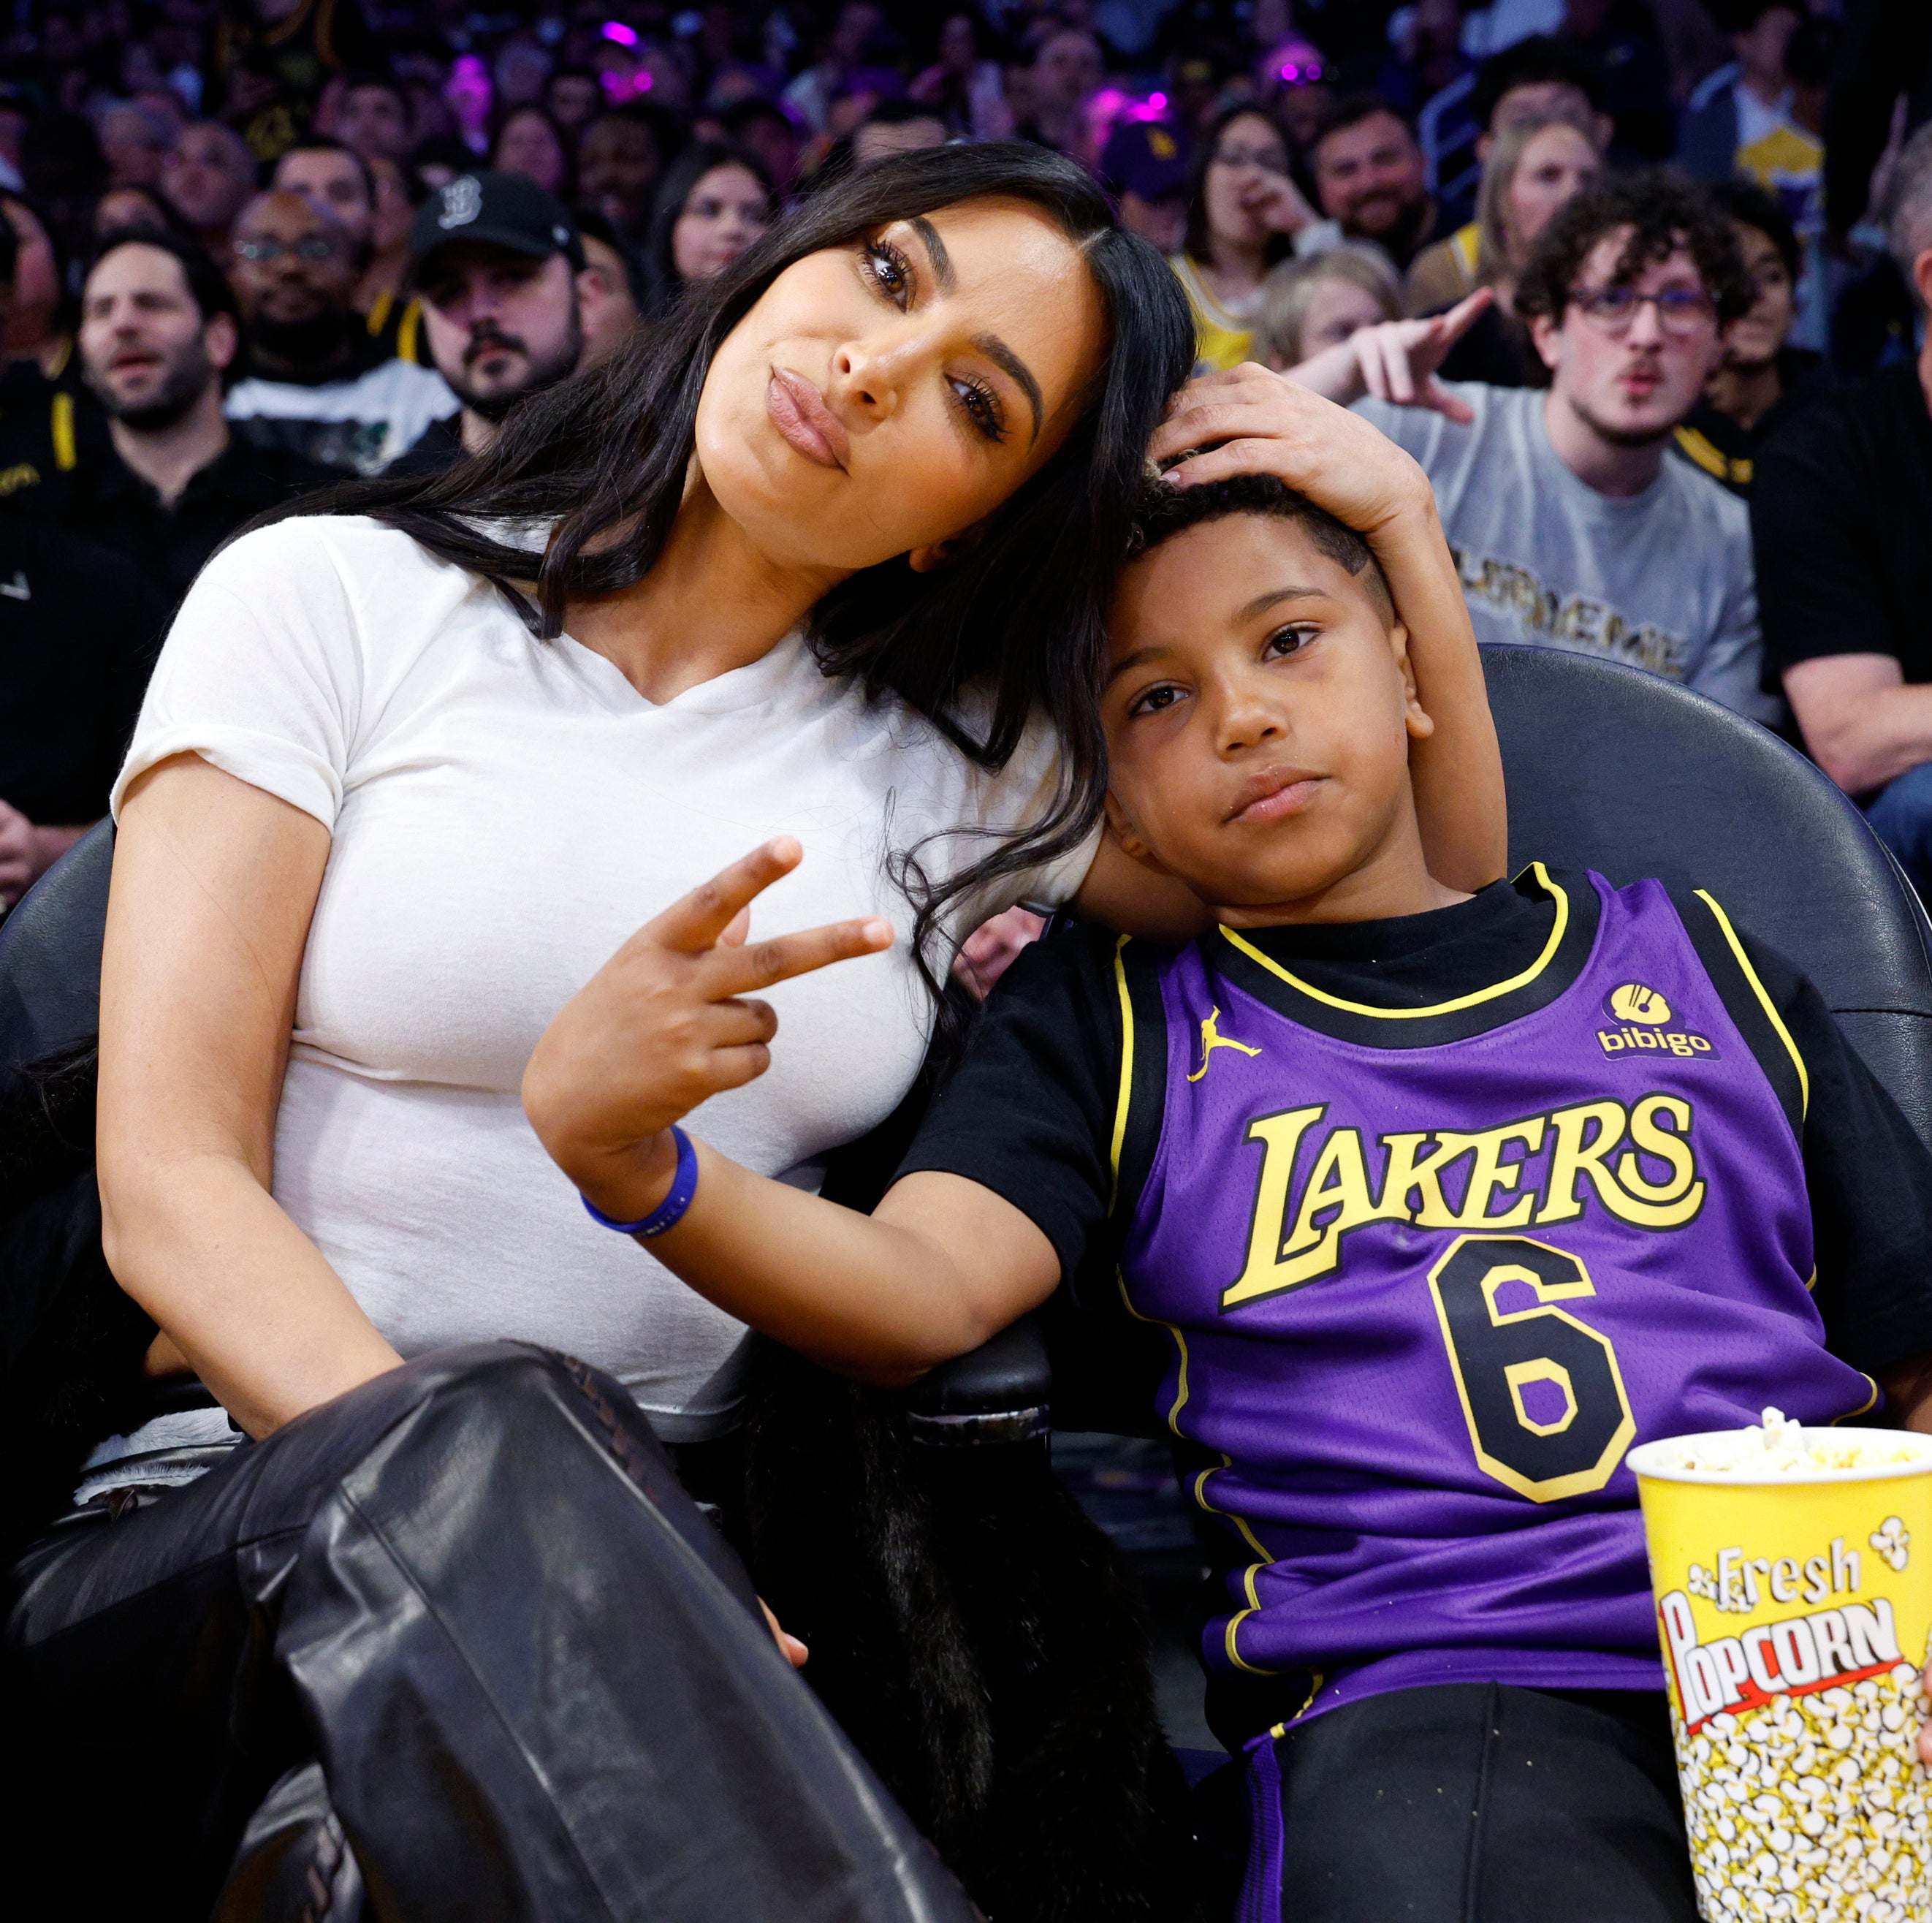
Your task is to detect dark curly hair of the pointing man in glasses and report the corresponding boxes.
[1517,166,1756,323]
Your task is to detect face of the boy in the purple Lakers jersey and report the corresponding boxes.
[1101,514,1431,926]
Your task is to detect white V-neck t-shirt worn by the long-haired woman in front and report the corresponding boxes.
[114,516,1092,1440]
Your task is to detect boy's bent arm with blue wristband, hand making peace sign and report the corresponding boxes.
[524,841,1105,1384]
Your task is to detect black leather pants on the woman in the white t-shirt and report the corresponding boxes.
[6,1343,975,1923]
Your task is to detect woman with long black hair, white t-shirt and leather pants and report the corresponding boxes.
[12,147,1501,1915]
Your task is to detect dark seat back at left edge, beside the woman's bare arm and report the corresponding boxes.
[0,822,114,1069]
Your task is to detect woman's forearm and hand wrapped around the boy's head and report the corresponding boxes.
[1152,365,1509,891]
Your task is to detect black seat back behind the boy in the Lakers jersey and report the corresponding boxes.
[1482,648,1932,1150]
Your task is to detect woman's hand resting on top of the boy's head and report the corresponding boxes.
[1148,361,1434,535]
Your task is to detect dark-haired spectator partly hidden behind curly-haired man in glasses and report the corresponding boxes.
[1677,180,1826,495]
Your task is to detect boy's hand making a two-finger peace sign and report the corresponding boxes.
[524,835,893,1221]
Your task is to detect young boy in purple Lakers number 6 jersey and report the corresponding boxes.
[525,475,1932,1923]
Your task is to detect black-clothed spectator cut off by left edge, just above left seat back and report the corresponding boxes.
[0,514,168,903]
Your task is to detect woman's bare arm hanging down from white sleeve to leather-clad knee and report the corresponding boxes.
[99,756,400,1436]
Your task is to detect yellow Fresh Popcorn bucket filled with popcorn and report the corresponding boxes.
[1629,1409,1932,1923]
